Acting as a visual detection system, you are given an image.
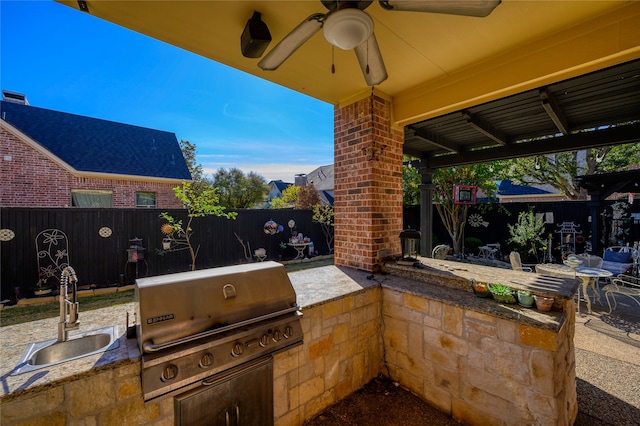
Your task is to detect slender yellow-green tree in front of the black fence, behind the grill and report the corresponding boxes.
[160,182,238,271]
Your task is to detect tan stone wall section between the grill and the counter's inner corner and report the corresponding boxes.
[273,287,382,426]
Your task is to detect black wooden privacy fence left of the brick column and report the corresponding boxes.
[0,207,329,300]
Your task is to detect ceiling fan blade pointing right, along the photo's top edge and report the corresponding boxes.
[378,0,501,18]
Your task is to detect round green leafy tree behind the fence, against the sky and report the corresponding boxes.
[213,168,269,209]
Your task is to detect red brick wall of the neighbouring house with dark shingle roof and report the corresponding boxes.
[0,128,182,209]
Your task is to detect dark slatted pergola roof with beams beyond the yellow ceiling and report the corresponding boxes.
[404,60,640,168]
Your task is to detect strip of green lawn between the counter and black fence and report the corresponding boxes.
[0,256,333,327]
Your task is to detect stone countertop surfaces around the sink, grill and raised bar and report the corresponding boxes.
[0,261,578,402]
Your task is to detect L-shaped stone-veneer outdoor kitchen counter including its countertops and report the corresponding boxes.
[0,259,577,426]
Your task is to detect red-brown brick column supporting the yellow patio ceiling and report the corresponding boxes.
[334,96,404,272]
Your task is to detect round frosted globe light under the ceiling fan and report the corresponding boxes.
[322,8,373,50]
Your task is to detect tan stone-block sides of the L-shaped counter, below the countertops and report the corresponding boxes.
[0,287,578,426]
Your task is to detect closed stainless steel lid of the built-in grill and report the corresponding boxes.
[135,262,298,353]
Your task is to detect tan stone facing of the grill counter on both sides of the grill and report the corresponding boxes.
[0,287,382,426]
